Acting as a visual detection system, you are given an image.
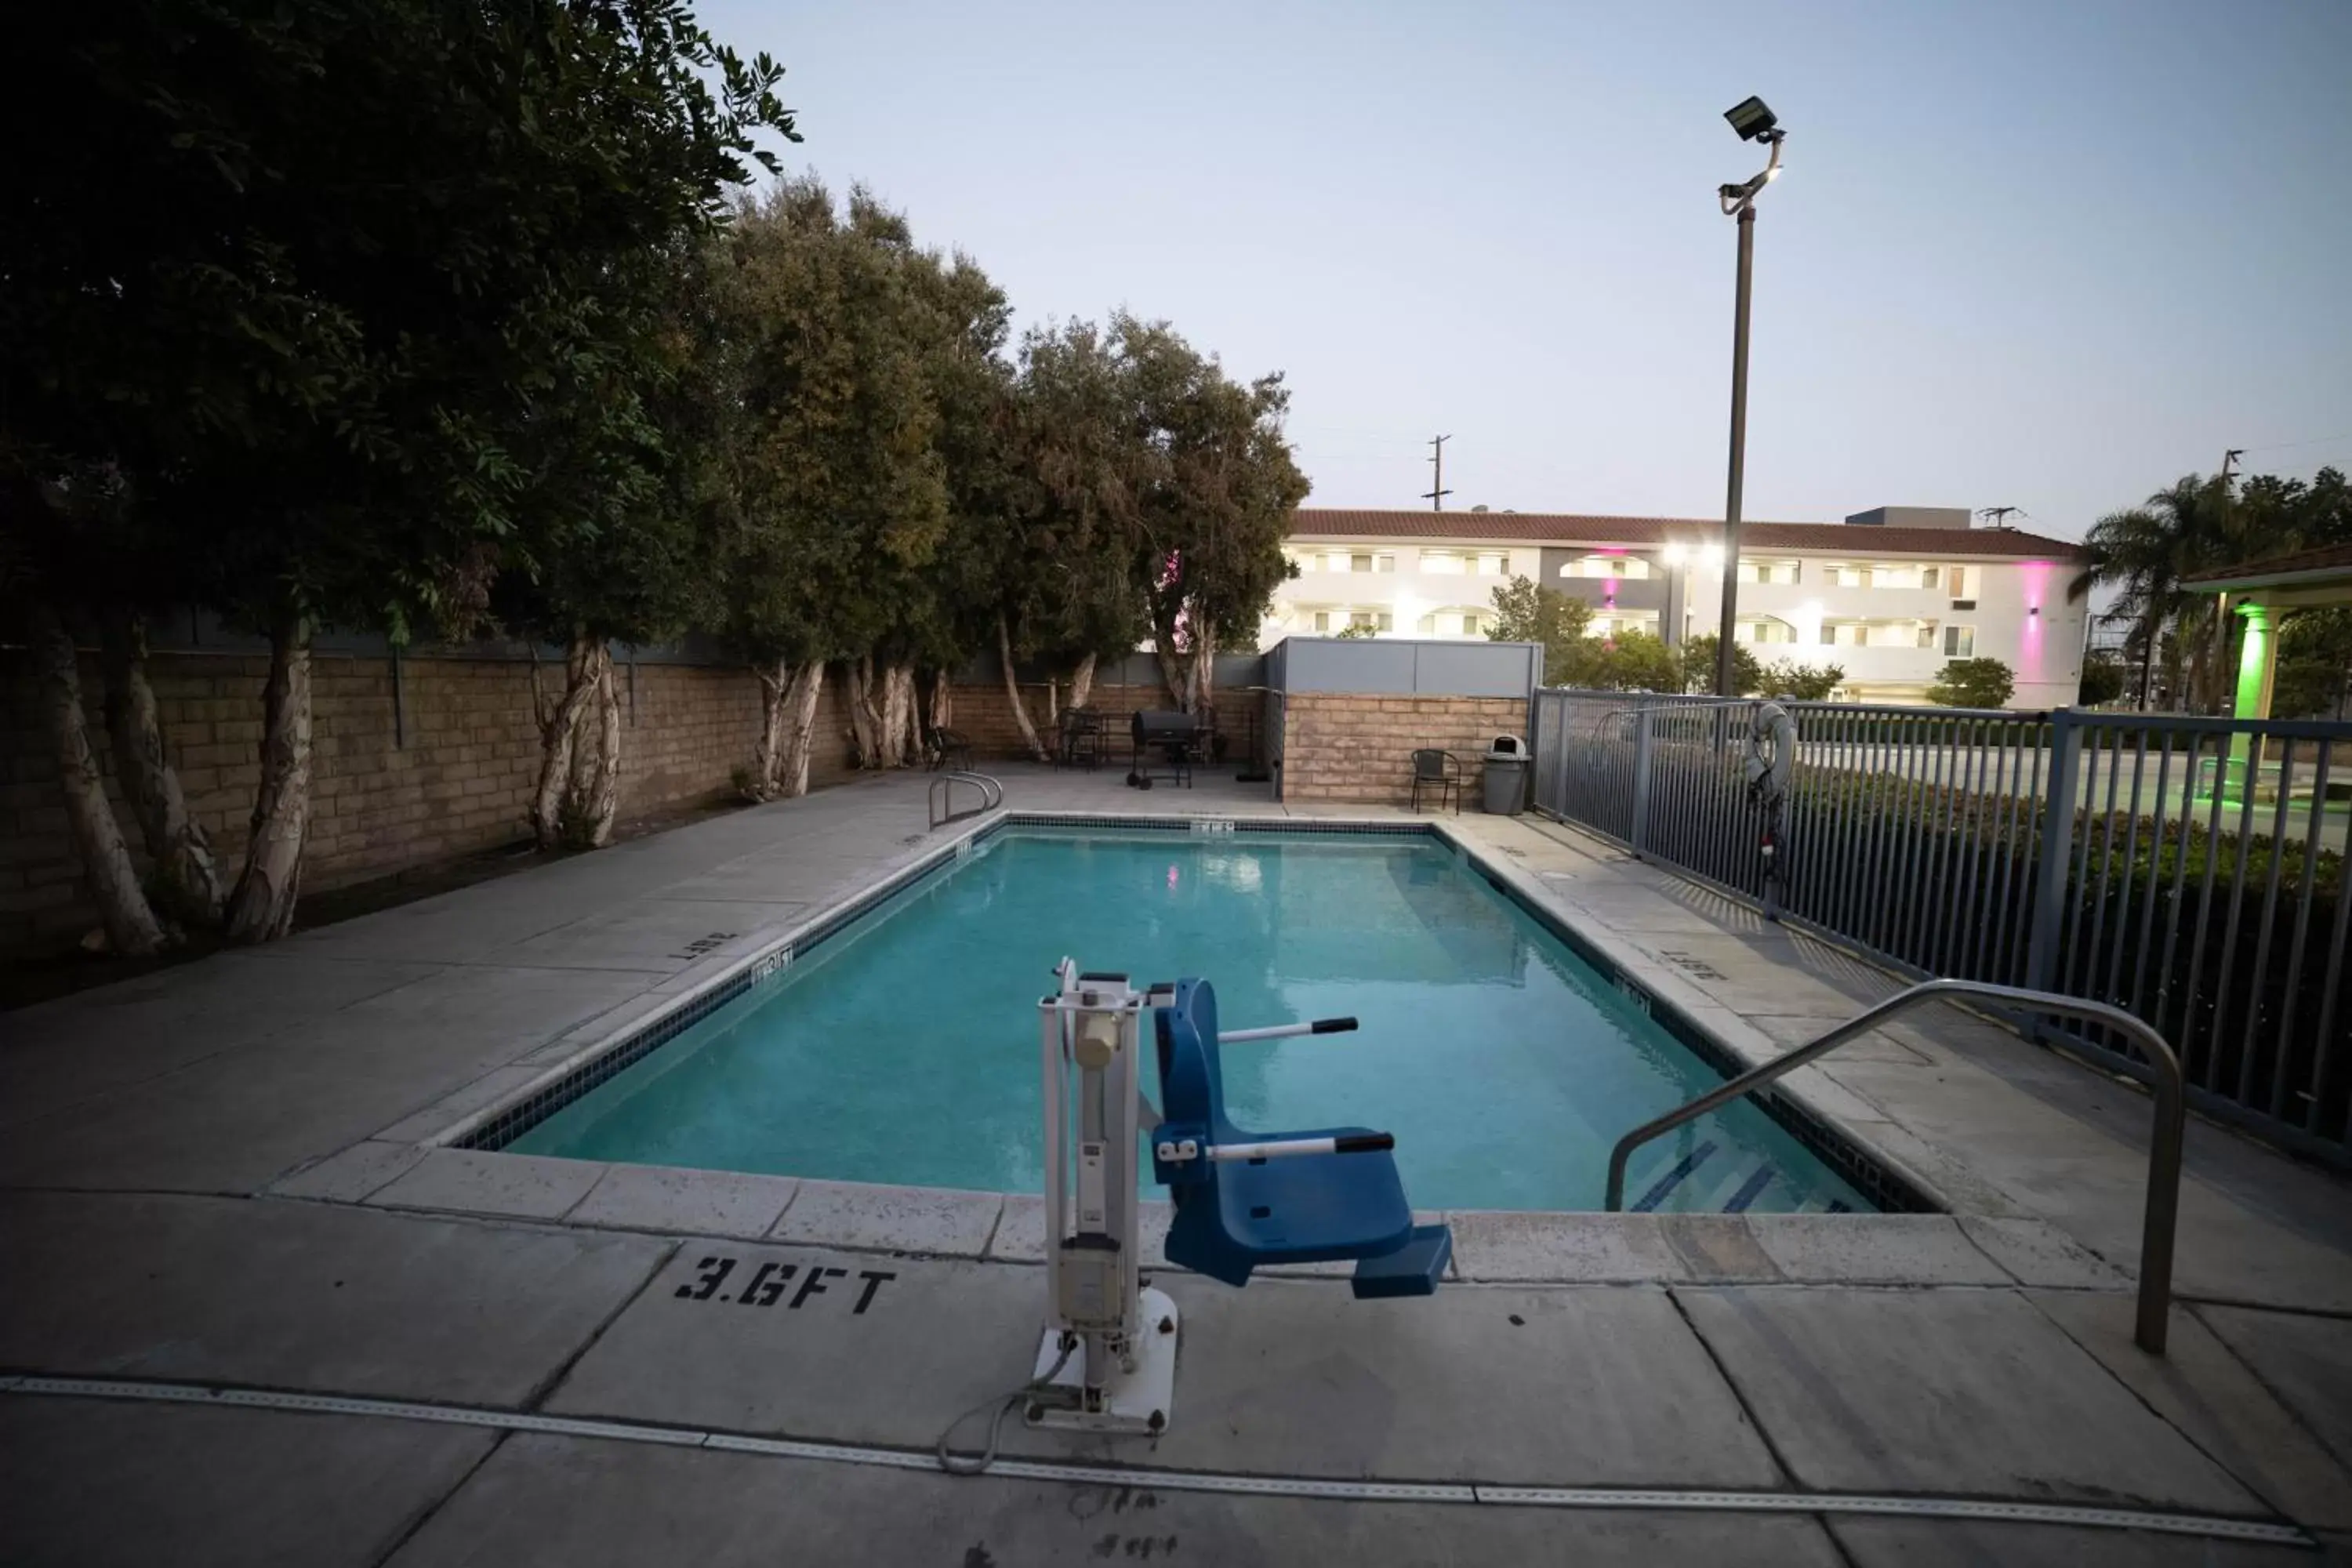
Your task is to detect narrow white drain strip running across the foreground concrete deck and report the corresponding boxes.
[0,1377,2317,1547]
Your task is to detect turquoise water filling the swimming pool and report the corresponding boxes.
[508,829,1870,1213]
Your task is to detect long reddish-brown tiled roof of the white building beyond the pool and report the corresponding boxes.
[1291,506,2082,560]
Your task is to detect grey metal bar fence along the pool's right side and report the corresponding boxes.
[1534,691,2352,1166]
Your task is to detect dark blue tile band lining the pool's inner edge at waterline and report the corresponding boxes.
[428,811,1947,1213]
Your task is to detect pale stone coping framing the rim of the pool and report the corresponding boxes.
[270,808,2129,1288]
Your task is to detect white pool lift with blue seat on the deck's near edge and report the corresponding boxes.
[1025,959,1454,1457]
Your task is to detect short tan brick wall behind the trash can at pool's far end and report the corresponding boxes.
[1282,691,1526,811]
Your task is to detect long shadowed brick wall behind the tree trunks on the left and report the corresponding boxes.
[0,652,861,952]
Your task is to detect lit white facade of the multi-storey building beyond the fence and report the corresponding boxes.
[1261,508,2086,708]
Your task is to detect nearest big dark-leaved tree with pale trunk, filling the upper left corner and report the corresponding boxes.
[0,0,790,940]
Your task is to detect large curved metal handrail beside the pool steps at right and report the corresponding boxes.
[1609,980,2187,1356]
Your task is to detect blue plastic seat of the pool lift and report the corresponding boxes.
[1152,980,1454,1298]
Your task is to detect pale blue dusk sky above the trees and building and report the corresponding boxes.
[699,0,2352,536]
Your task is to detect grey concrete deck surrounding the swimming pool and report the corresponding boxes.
[0,769,2352,1568]
